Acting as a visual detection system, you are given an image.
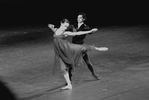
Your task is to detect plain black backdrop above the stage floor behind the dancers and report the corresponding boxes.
[0,0,149,28]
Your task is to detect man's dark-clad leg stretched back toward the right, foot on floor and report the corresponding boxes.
[83,53,100,80]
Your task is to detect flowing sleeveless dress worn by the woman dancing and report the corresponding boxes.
[53,34,95,76]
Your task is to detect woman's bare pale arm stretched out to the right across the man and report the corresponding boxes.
[63,28,98,36]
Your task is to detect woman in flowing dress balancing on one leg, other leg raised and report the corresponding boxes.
[48,19,108,89]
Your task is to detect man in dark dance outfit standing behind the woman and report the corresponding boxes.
[69,13,100,80]
